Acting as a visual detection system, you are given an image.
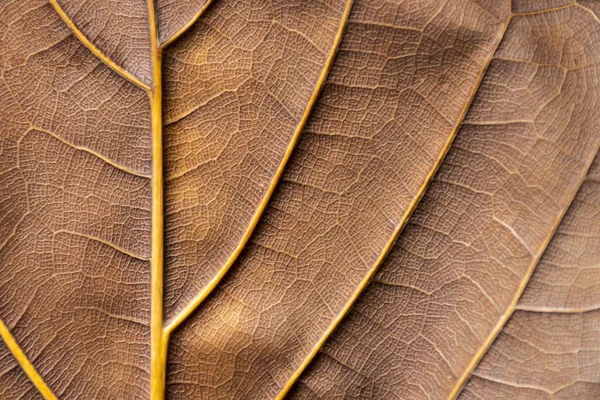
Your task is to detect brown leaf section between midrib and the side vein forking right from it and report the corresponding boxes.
[163,0,354,321]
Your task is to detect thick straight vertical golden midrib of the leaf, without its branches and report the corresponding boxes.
[147,0,167,400]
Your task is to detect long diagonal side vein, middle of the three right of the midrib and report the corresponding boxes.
[276,7,510,400]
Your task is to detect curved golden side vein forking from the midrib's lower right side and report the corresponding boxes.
[165,0,354,338]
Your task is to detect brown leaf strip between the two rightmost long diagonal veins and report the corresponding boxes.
[284,1,600,399]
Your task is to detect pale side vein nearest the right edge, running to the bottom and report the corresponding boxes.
[448,150,598,400]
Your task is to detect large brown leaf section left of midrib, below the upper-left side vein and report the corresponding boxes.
[0,0,150,399]
